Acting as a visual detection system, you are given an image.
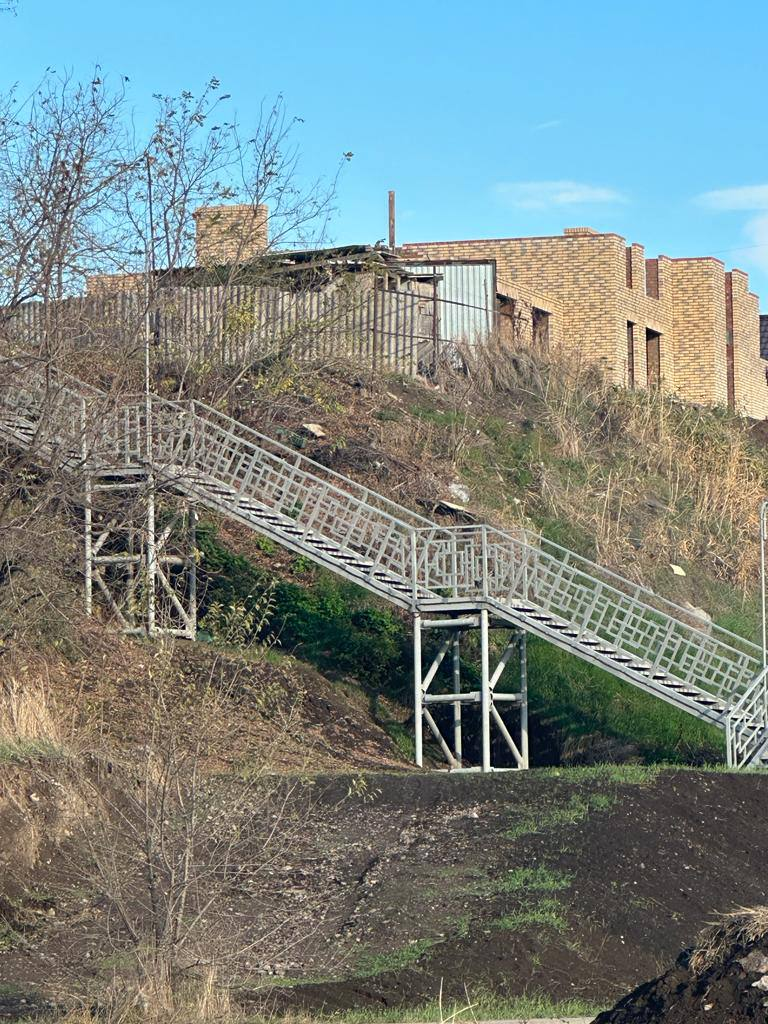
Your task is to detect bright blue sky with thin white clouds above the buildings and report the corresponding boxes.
[0,0,768,310]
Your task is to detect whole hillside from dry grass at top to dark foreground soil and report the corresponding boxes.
[0,339,768,1024]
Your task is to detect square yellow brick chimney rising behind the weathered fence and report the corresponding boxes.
[194,204,269,266]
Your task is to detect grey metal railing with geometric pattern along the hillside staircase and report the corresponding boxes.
[0,354,766,757]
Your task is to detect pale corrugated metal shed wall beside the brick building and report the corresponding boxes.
[404,260,496,344]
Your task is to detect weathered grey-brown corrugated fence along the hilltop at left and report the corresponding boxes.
[10,284,436,375]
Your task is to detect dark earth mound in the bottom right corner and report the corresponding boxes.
[595,909,768,1024]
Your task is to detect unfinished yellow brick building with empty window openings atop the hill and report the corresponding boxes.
[401,227,768,419]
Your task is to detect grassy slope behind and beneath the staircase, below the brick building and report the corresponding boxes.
[164,350,768,763]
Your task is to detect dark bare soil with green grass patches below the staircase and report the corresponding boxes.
[0,767,768,1010]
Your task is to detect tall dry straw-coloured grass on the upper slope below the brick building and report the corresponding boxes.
[443,342,768,591]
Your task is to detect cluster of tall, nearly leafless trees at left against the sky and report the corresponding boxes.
[0,69,352,643]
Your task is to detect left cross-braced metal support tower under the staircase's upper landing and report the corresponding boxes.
[83,472,198,639]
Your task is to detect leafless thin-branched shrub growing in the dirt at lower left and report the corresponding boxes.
[77,646,332,1011]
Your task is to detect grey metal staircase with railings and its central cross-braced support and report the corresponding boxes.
[0,359,768,770]
